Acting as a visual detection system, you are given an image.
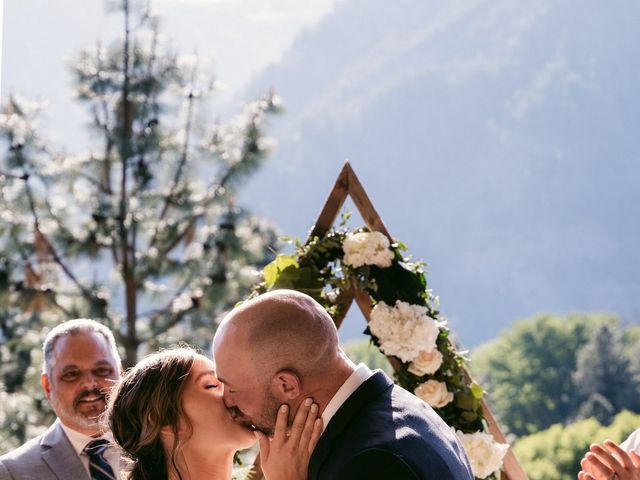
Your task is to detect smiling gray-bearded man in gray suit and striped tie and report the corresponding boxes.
[0,319,121,480]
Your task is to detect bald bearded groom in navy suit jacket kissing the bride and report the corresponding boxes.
[213,290,473,480]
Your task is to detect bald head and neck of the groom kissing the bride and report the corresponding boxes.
[213,290,355,434]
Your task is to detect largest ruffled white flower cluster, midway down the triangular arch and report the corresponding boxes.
[369,300,440,362]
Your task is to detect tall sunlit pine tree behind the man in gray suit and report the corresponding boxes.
[0,0,278,450]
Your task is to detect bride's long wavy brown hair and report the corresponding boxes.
[105,347,198,480]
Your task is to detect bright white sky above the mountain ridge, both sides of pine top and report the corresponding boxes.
[0,0,340,104]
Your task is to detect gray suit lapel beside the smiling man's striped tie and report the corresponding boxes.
[40,422,89,479]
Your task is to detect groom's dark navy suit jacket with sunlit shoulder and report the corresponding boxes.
[309,370,473,480]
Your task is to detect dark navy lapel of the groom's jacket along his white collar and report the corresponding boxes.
[309,370,393,480]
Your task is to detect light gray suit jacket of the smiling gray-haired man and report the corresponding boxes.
[0,422,89,480]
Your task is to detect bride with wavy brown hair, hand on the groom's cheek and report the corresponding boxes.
[106,347,322,480]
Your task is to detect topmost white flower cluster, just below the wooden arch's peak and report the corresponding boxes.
[342,232,394,268]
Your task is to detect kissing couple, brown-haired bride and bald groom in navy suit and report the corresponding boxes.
[110,290,473,480]
